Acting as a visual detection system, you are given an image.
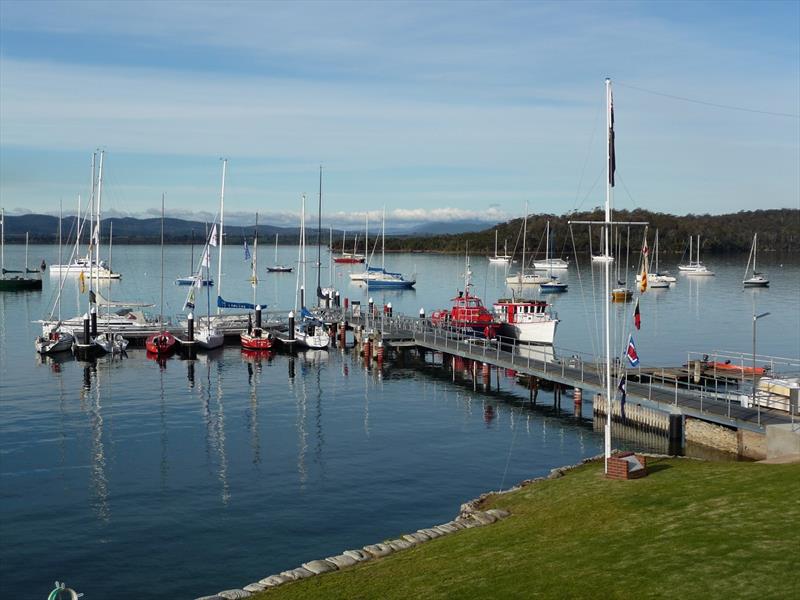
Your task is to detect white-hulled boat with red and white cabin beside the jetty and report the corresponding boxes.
[494,298,558,345]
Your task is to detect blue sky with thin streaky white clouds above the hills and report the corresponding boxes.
[0,0,800,228]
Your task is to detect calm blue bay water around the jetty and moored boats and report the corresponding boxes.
[0,246,800,600]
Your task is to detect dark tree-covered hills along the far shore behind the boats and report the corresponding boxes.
[5,209,800,256]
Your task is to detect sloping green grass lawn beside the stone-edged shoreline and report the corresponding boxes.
[253,459,800,600]
